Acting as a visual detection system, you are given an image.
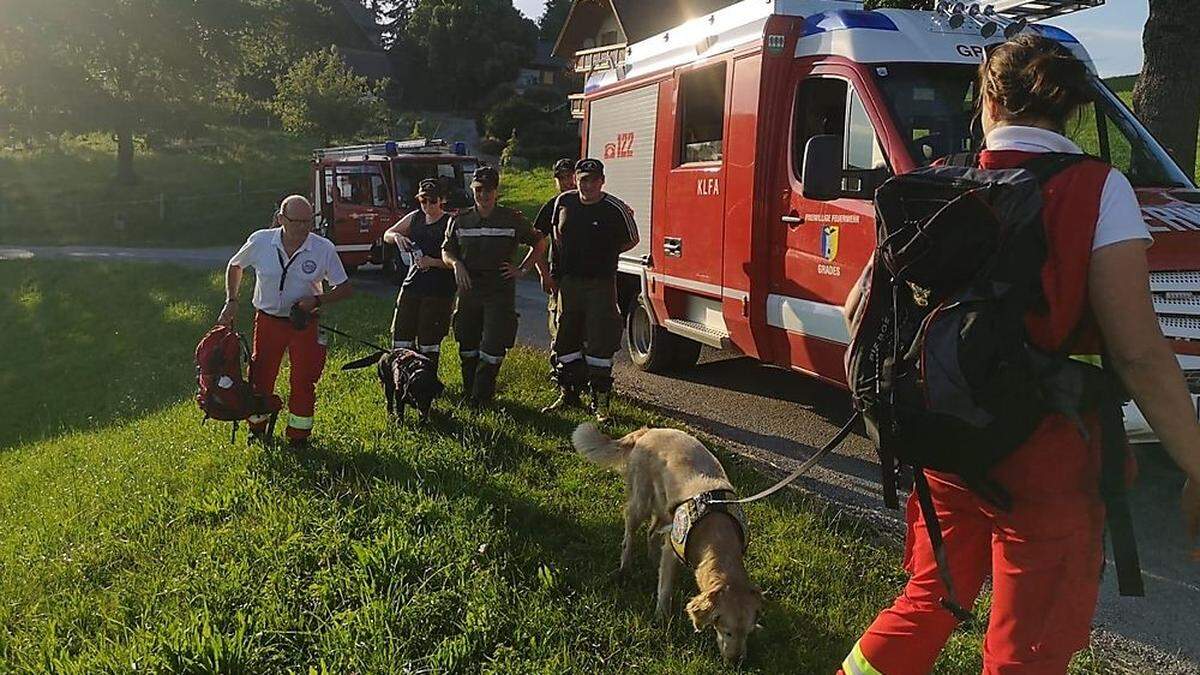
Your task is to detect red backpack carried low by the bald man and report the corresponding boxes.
[196,325,283,440]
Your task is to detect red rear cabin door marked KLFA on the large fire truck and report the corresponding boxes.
[652,62,727,305]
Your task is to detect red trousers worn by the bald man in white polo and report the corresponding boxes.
[250,311,325,441]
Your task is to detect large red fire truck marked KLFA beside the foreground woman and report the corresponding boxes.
[583,0,1200,441]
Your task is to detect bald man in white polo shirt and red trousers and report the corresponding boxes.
[217,195,350,446]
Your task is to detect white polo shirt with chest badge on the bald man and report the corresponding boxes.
[229,227,349,317]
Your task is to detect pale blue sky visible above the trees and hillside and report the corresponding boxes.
[514,0,1150,77]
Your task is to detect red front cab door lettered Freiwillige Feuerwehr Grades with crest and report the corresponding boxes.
[767,72,888,381]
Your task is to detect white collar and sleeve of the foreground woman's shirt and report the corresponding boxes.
[988,126,1153,251]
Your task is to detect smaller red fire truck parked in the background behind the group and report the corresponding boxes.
[312,138,479,273]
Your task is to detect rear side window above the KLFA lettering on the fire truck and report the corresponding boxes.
[679,64,725,163]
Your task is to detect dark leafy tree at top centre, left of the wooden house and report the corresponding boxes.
[400,0,538,109]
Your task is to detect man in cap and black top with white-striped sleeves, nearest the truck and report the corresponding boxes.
[546,159,638,422]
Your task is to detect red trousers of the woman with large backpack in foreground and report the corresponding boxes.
[839,417,1104,675]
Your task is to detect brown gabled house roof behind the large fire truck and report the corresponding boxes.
[553,0,736,58]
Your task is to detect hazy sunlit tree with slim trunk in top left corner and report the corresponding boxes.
[0,0,252,183]
